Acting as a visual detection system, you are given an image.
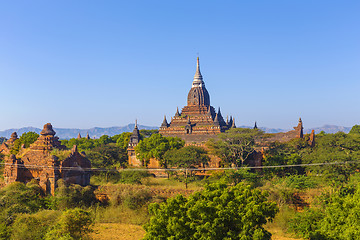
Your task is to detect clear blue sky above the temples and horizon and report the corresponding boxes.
[0,0,360,130]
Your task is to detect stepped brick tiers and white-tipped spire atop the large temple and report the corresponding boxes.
[159,58,235,143]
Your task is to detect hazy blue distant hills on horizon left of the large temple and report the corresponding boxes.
[0,123,158,139]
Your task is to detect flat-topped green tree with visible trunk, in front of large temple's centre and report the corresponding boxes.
[164,146,210,188]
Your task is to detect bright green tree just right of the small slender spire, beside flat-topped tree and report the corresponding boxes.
[135,133,185,168]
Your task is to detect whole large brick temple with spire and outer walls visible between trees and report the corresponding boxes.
[128,58,315,168]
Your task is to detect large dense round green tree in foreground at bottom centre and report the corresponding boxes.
[144,183,278,240]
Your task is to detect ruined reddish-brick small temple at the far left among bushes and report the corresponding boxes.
[1,123,91,194]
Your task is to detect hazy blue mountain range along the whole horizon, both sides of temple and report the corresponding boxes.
[0,124,351,139]
